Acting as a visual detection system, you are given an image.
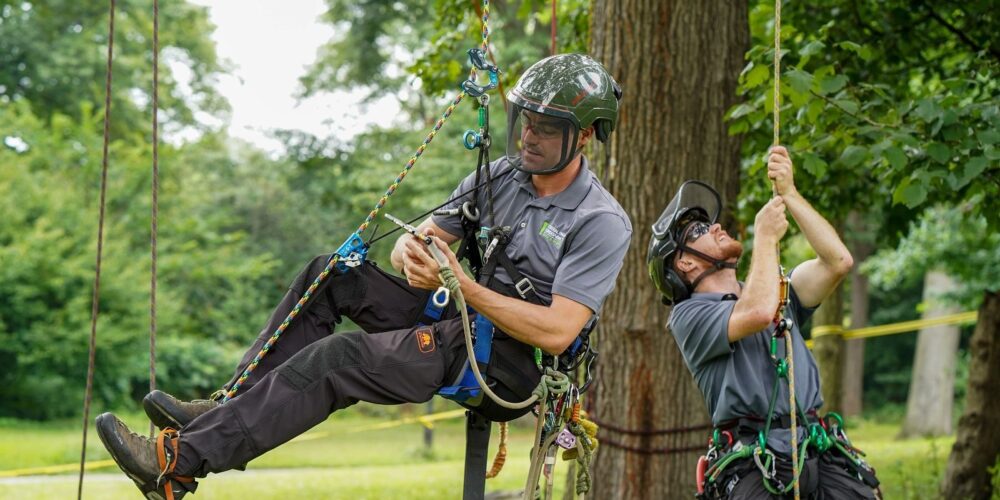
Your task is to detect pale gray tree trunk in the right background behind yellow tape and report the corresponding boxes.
[900,270,959,437]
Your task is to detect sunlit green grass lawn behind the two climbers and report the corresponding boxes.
[0,404,953,499]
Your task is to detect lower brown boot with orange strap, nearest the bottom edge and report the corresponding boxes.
[97,413,198,500]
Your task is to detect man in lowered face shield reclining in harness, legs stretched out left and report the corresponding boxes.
[97,54,632,498]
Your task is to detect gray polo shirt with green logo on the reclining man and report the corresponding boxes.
[433,158,632,313]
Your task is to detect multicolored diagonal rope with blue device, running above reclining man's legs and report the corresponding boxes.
[222,0,490,402]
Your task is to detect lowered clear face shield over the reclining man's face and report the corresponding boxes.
[507,104,580,174]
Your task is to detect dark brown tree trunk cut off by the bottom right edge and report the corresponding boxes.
[941,292,1000,500]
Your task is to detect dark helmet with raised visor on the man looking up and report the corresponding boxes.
[646,181,736,305]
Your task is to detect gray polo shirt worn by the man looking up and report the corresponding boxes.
[668,276,823,453]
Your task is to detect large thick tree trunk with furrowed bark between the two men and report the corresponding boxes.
[589,0,748,499]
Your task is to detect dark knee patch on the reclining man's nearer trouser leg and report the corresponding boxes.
[277,332,364,390]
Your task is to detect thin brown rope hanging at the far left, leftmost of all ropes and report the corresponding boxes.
[76,0,115,499]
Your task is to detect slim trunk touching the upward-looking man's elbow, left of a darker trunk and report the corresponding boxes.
[813,285,844,412]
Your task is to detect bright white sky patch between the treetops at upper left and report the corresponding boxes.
[192,0,399,152]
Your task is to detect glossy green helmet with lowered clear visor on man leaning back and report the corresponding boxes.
[507,54,622,174]
